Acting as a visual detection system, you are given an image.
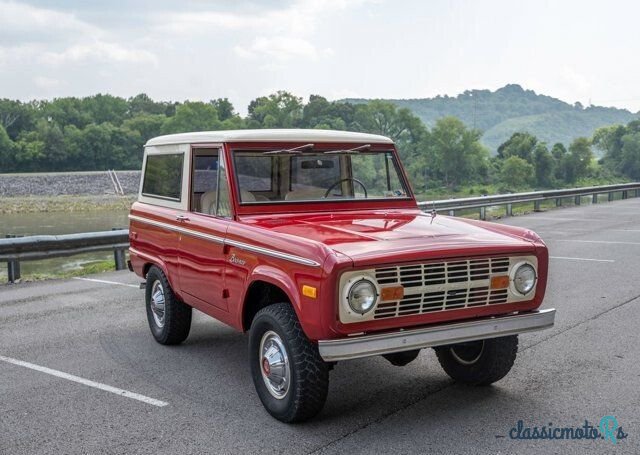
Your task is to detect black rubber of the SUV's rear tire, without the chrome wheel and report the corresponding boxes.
[145,265,192,345]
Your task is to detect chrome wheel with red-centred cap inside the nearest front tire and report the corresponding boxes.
[260,330,291,400]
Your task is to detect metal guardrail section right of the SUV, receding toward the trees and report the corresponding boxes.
[418,182,640,220]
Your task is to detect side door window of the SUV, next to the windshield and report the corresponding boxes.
[191,149,231,217]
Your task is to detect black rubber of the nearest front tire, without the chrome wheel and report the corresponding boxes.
[249,303,329,423]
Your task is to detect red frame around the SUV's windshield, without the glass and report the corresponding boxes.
[228,142,417,215]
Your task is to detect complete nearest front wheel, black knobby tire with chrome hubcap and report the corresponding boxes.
[249,303,329,423]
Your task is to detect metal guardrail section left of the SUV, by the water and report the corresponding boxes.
[0,229,129,283]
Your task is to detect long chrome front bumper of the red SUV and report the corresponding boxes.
[318,309,556,362]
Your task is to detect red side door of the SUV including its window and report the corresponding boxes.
[179,148,231,311]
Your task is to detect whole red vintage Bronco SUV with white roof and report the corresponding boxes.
[129,130,555,422]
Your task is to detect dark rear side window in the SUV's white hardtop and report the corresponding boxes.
[142,153,184,201]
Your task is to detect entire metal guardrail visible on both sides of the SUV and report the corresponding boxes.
[0,182,640,283]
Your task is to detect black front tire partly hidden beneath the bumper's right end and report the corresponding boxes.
[434,335,518,386]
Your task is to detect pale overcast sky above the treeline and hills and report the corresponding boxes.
[0,0,640,113]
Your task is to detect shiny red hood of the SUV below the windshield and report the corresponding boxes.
[243,210,535,265]
